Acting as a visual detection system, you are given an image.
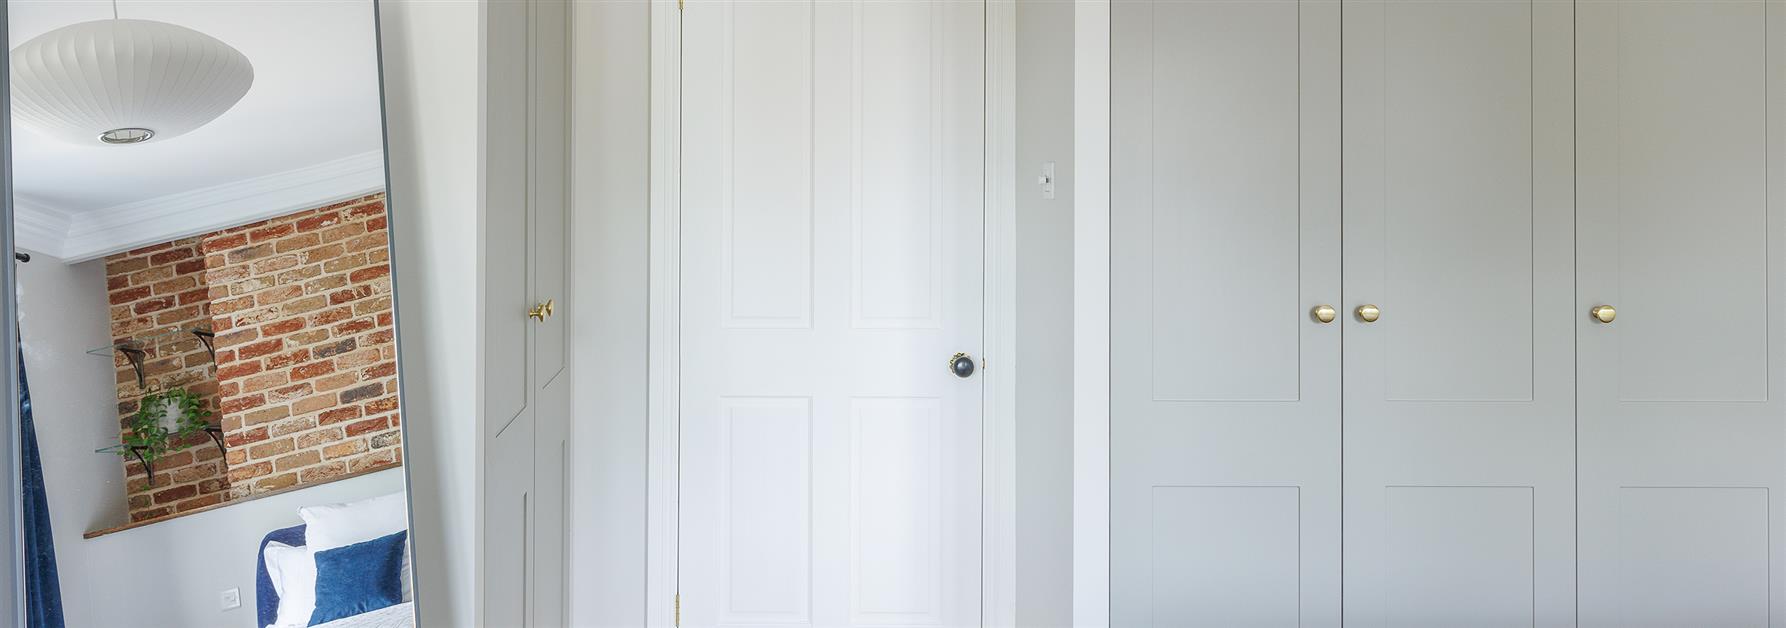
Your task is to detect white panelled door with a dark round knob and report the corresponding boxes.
[677,0,984,626]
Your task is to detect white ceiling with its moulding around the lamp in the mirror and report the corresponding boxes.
[7,0,382,259]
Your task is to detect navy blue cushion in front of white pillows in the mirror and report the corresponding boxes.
[311,532,409,626]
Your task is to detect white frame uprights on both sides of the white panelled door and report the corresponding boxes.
[645,0,1021,626]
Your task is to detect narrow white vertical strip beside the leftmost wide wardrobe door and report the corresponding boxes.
[1073,0,1111,628]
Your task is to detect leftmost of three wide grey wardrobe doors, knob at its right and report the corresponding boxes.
[1111,0,1340,626]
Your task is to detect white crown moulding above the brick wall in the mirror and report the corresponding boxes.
[13,150,384,264]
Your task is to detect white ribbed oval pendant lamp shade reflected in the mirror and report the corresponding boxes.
[13,20,254,146]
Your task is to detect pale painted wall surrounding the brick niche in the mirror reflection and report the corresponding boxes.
[18,255,404,628]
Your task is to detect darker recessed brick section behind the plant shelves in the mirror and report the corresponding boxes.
[105,237,229,521]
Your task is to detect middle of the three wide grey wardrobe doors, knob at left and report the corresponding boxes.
[1343,0,1579,626]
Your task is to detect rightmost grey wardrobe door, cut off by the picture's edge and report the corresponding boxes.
[1573,0,1786,626]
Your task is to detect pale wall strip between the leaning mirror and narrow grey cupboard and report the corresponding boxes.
[379,0,482,626]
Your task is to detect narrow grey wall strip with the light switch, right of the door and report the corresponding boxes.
[1016,0,1073,628]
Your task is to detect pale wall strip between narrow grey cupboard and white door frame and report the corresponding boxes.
[570,0,650,626]
